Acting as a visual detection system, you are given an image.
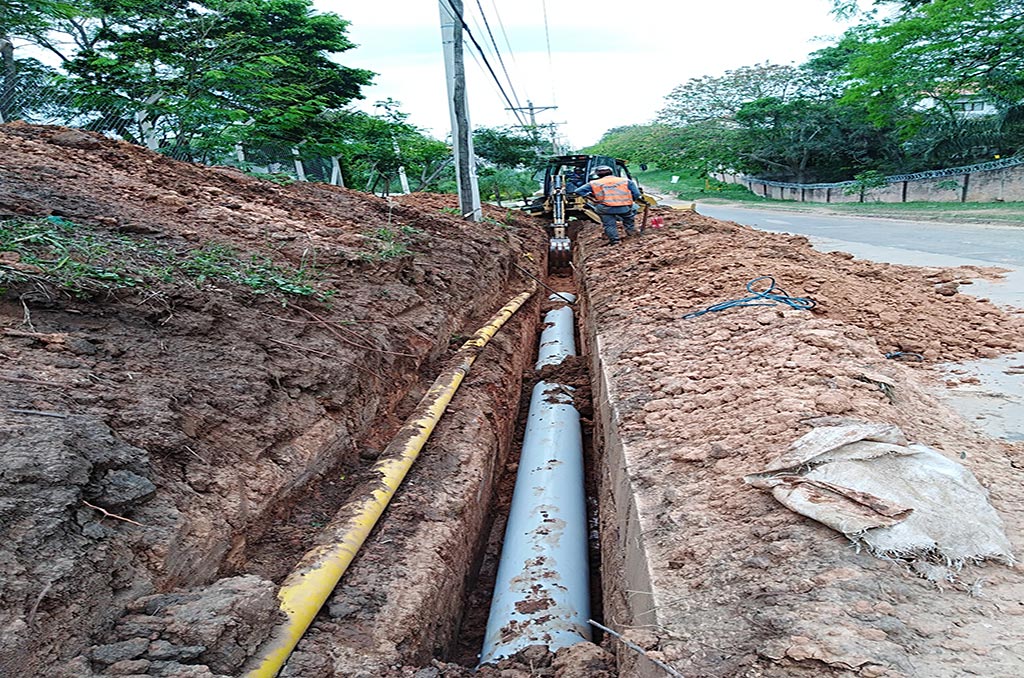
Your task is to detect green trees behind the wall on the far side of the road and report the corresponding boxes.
[592,0,1024,182]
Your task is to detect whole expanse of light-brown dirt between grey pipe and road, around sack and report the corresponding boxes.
[584,212,1024,677]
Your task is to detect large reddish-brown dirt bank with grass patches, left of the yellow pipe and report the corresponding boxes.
[0,124,540,675]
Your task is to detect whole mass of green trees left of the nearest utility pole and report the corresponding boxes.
[0,0,464,196]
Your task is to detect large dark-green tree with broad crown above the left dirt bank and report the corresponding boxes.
[12,0,372,159]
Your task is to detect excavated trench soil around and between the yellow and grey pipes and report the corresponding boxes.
[260,266,615,678]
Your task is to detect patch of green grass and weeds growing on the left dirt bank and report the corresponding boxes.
[0,216,333,300]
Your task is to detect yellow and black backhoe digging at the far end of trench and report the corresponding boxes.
[522,156,657,270]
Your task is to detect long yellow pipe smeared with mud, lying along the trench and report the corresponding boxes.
[245,285,537,678]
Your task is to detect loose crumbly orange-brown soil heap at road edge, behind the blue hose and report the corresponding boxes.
[594,211,1024,362]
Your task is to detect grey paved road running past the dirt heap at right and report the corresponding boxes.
[697,204,1024,267]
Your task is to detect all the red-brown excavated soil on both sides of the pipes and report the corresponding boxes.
[6,124,1024,678]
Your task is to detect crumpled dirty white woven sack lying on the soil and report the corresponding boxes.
[744,421,1014,583]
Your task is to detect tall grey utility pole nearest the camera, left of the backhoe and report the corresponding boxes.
[437,0,483,221]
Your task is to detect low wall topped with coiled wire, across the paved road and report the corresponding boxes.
[712,157,1024,203]
